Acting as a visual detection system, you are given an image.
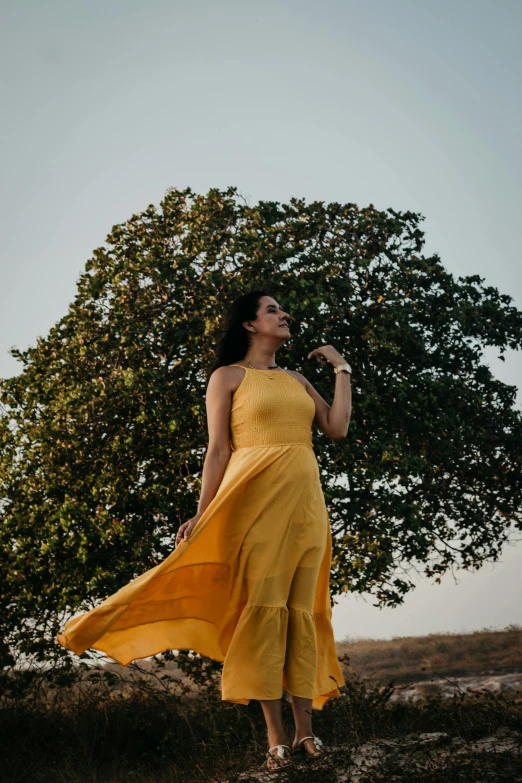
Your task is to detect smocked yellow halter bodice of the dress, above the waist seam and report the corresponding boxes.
[226,364,315,451]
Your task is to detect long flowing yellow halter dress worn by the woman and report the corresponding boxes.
[57,365,345,709]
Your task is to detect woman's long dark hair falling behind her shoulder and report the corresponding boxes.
[203,290,270,382]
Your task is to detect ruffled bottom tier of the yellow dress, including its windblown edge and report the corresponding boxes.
[57,604,345,710]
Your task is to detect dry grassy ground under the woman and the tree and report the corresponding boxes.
[0,629,522,783]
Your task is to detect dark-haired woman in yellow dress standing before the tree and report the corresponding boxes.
[58,291,351,770]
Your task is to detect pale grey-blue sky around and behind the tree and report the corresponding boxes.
[0,0,522,639]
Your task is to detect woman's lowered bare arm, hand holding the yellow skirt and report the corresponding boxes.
[176,367,233,546]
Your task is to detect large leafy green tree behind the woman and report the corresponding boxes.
[0,187,522,664]
